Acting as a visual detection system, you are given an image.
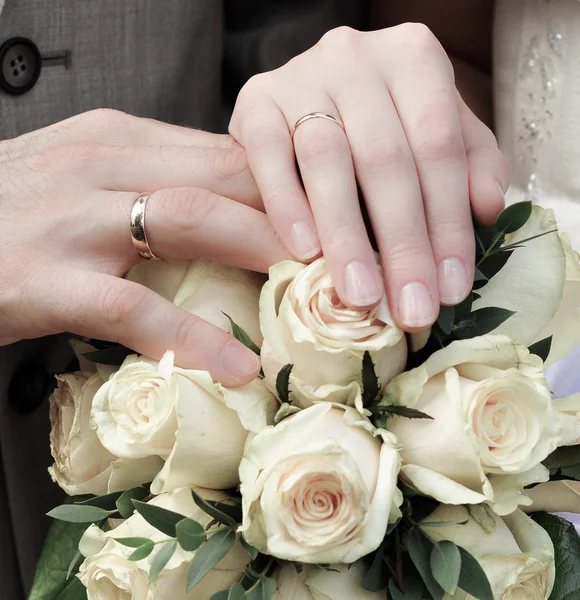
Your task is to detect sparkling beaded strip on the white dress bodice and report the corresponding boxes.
[517,23,564,201]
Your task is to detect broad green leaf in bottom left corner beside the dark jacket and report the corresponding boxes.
[29,520,87,600]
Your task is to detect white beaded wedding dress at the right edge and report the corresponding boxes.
[494,0,580,532]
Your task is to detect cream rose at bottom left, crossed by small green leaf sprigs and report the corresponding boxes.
[78,488,250,600]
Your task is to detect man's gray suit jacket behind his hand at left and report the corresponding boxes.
[0,0,367,600]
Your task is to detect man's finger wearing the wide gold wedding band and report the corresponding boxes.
[102,188,292,273]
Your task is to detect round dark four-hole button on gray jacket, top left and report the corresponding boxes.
[0,38,42,95]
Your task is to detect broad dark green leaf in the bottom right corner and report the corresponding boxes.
[533,513,580,600]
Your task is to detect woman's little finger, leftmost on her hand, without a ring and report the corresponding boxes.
[230,100,321,261]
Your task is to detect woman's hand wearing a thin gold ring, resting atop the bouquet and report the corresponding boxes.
[230,23,509,331]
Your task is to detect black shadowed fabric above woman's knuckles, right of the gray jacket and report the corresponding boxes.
[224,0,369,101]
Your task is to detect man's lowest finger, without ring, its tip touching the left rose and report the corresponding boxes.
[39,270,260,386]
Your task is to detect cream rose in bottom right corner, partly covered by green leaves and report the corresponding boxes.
[423,505,556,600]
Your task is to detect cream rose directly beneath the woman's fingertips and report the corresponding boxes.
[260,258,407,407]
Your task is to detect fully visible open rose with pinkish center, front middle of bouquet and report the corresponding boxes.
[240,402,402,563]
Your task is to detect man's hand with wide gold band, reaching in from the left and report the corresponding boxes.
[0,110,289,385]
